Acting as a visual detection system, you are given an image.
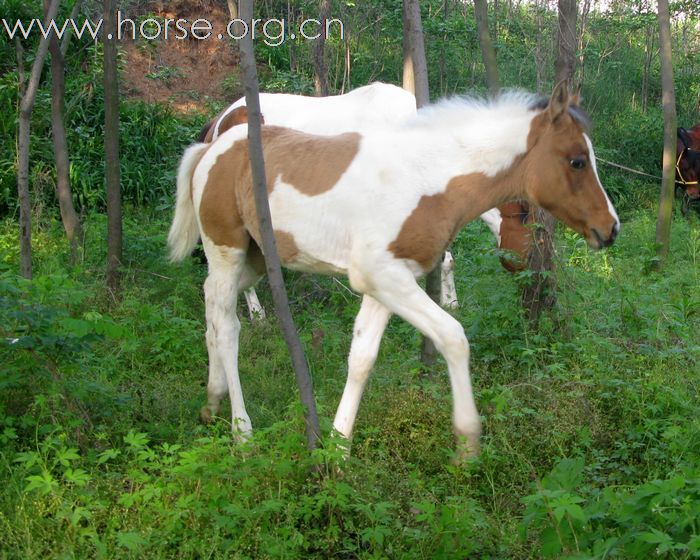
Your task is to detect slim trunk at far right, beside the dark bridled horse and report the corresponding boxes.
[656,0,677,269]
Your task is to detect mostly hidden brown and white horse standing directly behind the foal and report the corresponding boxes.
[198,82,533,319]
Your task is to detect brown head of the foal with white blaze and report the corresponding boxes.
[524,82,620,249]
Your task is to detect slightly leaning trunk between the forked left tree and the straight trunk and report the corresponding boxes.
[49,27,83,264]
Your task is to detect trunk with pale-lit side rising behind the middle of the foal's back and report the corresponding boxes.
[403,0,434,367]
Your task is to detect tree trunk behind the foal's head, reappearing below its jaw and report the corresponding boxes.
[522,0,577,327]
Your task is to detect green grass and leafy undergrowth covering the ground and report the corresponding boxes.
[0,207,700,559]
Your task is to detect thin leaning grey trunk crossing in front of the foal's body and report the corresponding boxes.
[240,0,321,449]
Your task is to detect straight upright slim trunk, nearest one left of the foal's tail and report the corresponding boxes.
[103,0,122,294]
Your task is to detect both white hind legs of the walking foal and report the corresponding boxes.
[200,246,252,436]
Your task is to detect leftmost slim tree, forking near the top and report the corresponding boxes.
[15,0,60,278]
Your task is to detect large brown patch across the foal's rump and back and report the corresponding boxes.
[199,126,360,250]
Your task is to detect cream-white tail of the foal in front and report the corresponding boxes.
[168,144,209,262]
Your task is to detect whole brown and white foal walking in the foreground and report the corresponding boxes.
[168,85,620,460]
